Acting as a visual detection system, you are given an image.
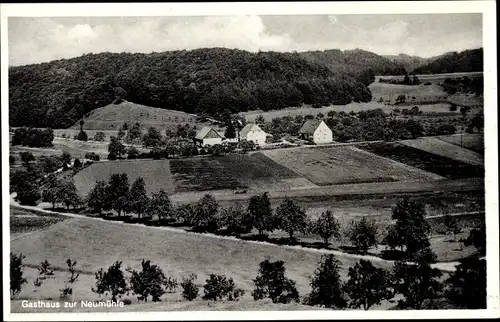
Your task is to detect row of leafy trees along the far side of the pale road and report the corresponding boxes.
[86,174,486,262]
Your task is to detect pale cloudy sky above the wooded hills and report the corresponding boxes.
[8,13,483,66]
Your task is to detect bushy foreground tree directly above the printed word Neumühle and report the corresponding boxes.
[92,261,127,302]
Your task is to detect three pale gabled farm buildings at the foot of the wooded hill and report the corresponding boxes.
[194,119,333,146]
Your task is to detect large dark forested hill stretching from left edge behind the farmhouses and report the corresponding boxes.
[9,48,382,128]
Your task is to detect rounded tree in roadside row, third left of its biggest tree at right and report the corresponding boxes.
[275,197,307,240]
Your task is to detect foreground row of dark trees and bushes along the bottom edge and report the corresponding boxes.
[10,253,486,310]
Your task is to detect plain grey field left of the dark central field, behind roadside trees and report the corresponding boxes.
[74,160,174,196]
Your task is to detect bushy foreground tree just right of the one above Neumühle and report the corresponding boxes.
[129,259,166,302]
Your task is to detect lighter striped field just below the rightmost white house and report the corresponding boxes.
[262,146,441,185]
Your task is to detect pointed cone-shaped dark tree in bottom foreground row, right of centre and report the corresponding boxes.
[305,254,346,308]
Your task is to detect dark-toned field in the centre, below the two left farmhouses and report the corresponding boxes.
[170,153,315,192]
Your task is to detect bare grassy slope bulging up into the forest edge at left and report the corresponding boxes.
[71,101,219,131]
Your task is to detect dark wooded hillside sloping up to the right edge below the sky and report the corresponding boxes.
[414,48,483,74]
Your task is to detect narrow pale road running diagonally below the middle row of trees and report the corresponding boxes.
[11,203,478,272]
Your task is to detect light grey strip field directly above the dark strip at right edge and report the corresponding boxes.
[401,137,484,166]
